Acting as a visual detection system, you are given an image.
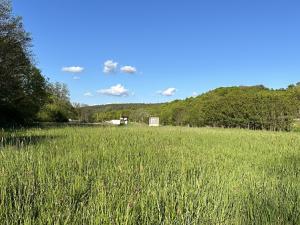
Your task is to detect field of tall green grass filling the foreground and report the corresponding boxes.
[0,126,300,225]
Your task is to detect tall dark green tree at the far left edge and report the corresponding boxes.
[0,0,47,124]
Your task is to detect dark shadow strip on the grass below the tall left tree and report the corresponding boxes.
[0,135,60,149]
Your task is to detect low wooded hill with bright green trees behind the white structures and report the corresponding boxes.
[77,83,300,130]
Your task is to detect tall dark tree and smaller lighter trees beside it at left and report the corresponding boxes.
[0,0,74,126]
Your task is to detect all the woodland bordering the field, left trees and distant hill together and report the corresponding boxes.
[0,0,300,131]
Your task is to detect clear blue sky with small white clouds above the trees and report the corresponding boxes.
[13,0,300,105]
